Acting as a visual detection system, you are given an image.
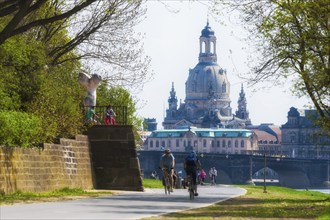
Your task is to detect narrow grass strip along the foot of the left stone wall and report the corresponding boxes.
[0,187,112,205]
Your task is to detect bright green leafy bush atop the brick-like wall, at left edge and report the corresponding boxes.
[0,111,42,147]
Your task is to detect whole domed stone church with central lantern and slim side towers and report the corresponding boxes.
[163,22,251,129]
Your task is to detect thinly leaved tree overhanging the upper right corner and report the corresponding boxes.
[214,0,330,130]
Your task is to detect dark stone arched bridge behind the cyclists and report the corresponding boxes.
[138,151,330,188]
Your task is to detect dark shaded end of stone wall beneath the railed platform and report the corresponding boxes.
[88,125,144,191]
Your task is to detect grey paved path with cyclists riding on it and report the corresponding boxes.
[0,185,246,220]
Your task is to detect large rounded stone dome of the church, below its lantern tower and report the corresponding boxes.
[186,64,230,100]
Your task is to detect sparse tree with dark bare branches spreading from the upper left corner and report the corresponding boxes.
[0,0,150,91]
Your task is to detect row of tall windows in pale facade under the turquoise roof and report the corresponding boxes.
[149,139,245,148]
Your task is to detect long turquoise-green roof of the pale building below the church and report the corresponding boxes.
[150,128,253,138]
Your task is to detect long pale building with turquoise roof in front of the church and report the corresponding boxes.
[143,127,258,154]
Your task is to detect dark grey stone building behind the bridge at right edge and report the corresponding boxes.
[281,107,330,158]
